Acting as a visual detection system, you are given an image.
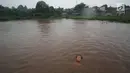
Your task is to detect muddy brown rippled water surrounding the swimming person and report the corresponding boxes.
[0,19,130,73]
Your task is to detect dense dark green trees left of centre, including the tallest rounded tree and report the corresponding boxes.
[0,1,63,20]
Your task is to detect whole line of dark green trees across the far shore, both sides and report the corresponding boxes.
[0,1,130,20]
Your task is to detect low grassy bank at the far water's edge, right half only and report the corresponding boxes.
[69,16,130,23]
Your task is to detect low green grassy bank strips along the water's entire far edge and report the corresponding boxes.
[0,16,130,23]
